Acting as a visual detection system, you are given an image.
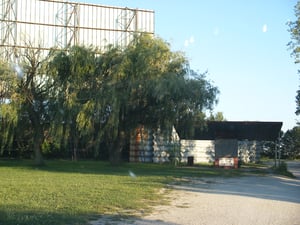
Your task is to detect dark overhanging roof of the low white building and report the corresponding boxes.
[184,121,282,141]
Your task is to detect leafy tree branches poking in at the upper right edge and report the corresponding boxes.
[288,1,300,115]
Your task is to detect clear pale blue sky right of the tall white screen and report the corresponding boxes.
[79,0,300,131]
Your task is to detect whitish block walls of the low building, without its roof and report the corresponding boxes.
[129,126,262,163]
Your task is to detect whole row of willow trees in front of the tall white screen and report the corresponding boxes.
[0,35,218,164]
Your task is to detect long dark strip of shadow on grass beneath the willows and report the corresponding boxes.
[0,157,262,178]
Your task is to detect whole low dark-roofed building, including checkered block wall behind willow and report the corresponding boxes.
[129,121,282,163]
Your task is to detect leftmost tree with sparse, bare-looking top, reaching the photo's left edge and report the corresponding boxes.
[0,47,52,165]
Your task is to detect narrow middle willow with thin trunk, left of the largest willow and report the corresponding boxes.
[47,46,101,160]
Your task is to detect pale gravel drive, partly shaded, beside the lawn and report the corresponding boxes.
[92,162,300,225]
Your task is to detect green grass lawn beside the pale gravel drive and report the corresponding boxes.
[0,160,264,225]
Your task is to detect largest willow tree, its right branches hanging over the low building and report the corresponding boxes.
[101,35,218,162]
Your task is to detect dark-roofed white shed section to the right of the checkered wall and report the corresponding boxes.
[178,121,282,163]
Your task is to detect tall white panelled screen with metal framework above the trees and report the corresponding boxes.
[0,0,154,61]
